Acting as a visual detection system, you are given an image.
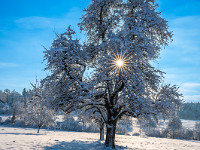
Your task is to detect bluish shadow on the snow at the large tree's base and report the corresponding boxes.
[44,140,127,150]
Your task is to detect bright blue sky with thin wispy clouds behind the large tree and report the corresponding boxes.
[0,0,200,101]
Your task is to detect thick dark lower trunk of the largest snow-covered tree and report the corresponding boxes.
[105,122,116,149]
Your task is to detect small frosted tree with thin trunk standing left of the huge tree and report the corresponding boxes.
[24,81,56,133]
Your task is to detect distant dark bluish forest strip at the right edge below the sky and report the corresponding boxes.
[178,102,200,120]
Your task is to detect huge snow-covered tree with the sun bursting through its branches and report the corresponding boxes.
[43,0,181,148]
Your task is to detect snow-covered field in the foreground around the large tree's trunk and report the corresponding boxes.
[0,126,200,150]
